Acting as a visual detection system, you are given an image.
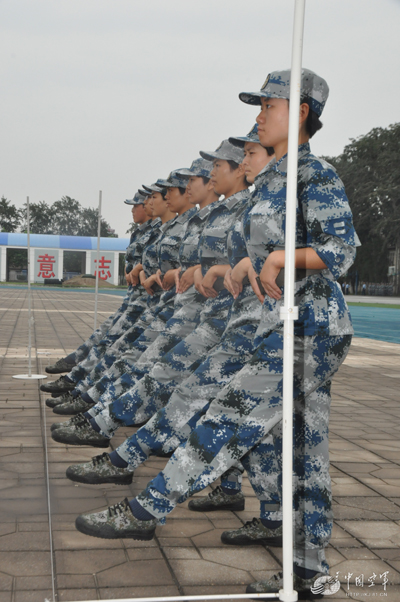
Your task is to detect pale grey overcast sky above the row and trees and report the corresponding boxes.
[0,0,400,237]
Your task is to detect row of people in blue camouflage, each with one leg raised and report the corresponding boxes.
[40,70,358,592]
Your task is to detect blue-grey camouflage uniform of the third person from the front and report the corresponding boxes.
[91,184,250,433]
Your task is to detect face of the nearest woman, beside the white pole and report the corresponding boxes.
[256,98,289,160]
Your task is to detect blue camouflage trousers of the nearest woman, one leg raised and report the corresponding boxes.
[137,327,351,572]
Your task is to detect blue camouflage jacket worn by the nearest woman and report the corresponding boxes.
[243,143,360,336]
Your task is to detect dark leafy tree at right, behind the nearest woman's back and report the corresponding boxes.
[327,123,400,282]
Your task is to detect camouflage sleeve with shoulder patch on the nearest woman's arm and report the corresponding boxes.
[299,161,360,279]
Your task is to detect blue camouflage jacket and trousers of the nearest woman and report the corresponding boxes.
[131,144,358,572]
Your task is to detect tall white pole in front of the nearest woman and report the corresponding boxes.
[279,0,305,602]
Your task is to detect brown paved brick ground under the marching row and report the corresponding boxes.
[0,289,400,602]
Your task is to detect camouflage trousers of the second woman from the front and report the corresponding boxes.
[109,287,281,506]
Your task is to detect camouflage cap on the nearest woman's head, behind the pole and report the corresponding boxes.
[239,69,329,117]
